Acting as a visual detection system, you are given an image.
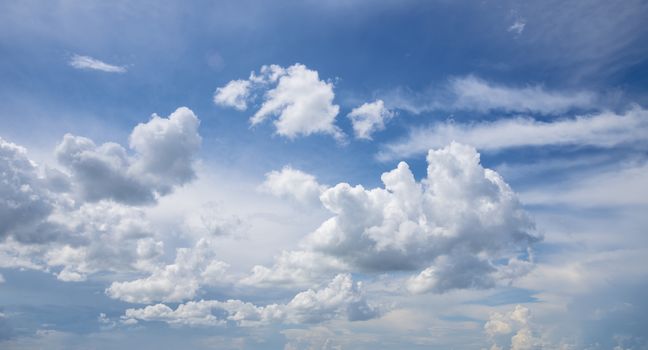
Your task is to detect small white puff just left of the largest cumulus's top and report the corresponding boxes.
[260,166,327,203]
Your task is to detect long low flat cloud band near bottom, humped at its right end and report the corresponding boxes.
[122,274,379,326]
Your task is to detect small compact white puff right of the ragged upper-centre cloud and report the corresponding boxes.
[347,100,394,140]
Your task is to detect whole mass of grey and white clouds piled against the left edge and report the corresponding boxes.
[0,107,201,281]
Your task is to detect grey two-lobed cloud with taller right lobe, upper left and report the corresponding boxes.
[56,107,201,204]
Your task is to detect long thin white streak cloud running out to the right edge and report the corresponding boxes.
[378,107,648,160]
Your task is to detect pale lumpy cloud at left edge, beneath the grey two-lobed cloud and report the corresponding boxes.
[0,202,163,281]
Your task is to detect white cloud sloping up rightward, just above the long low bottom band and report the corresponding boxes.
[106,239,229,304]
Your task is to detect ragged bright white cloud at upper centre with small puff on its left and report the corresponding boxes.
[214,64,344,139]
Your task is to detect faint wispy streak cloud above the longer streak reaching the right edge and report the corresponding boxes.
[383,75,596,115]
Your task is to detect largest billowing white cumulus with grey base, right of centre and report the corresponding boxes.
[247,143,539,293]
